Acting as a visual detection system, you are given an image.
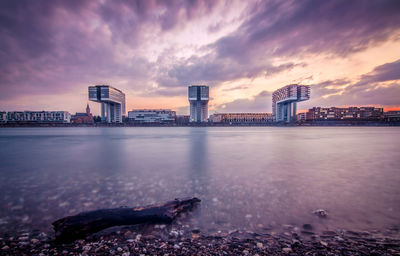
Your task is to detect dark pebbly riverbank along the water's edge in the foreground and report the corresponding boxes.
[0,225,400,256]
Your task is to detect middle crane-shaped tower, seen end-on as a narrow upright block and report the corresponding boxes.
[188,85,209,122]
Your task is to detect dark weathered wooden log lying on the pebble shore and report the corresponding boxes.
[53,197,200,242]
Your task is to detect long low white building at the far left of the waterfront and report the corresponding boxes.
[7,111,71,123]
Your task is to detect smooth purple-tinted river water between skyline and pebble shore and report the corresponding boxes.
[0,127,400,237]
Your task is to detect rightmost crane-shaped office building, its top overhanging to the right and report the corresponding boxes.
[272,84,310,122]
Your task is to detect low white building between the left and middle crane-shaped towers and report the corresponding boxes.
[128,109,176,123]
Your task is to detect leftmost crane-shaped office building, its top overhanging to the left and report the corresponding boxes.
[89,85,125,123]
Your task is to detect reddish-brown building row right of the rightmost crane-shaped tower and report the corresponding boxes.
[306,107,384,120]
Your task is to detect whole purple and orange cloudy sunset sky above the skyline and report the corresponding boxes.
[0,0,400,114]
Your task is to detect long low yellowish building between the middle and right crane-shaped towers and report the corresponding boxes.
[210,113,273,124]
